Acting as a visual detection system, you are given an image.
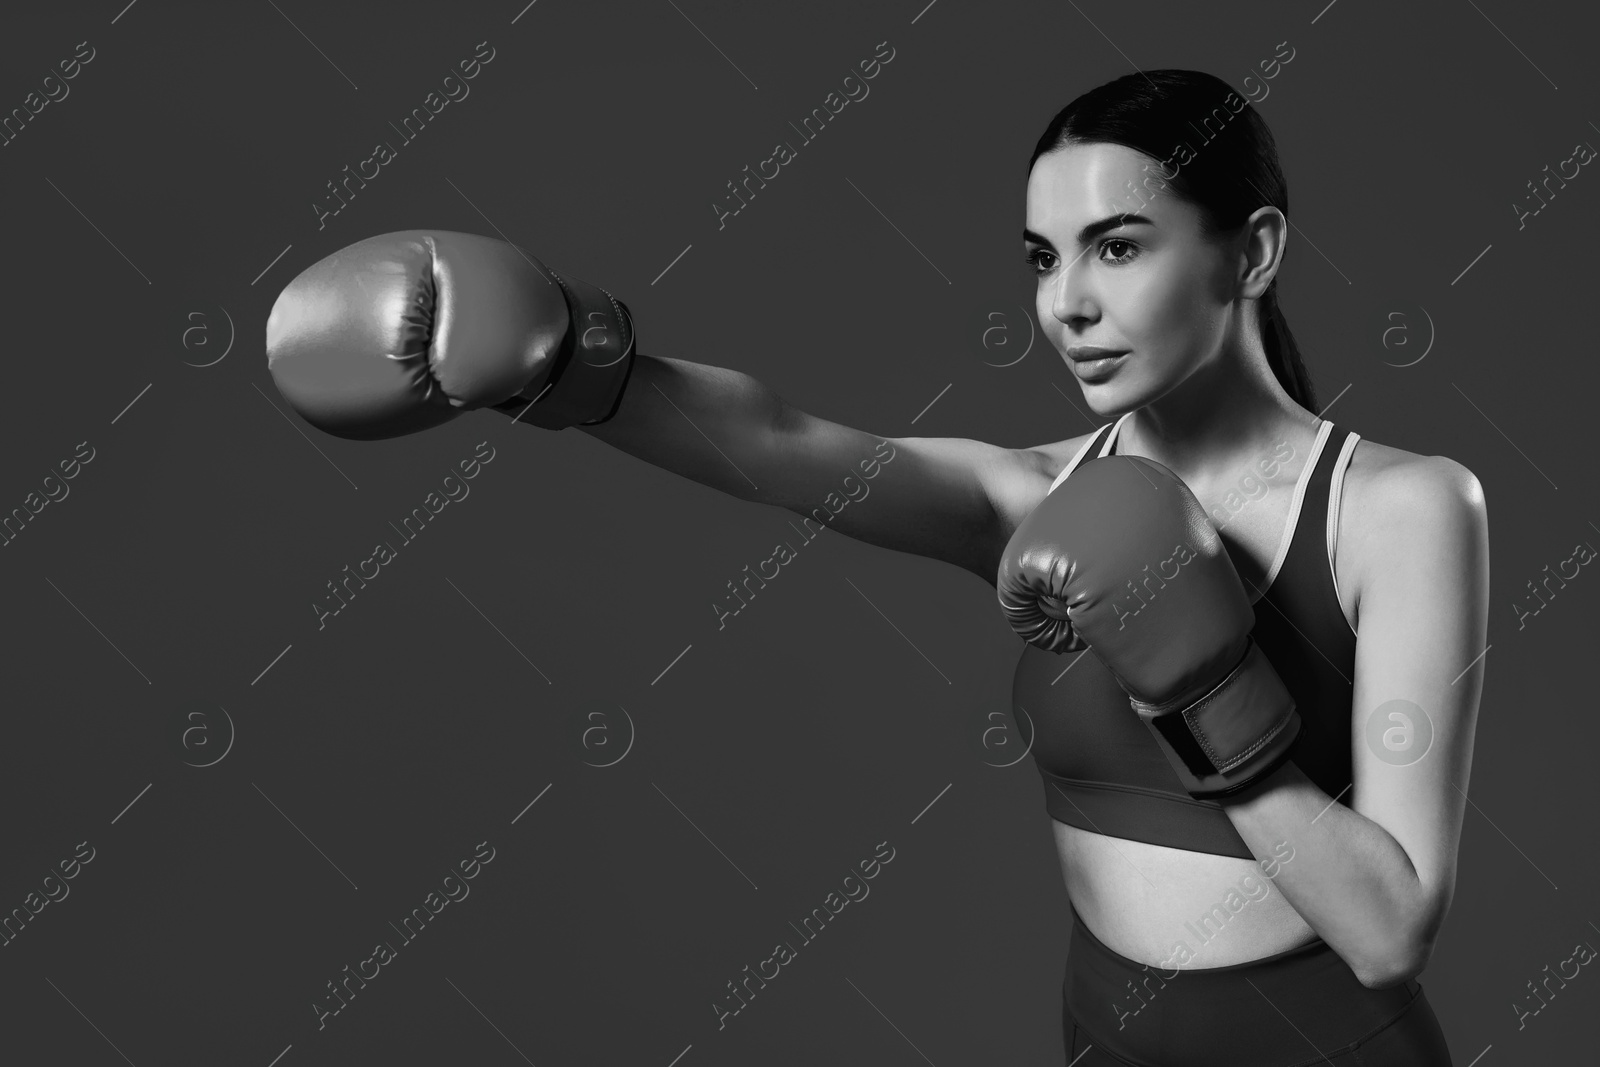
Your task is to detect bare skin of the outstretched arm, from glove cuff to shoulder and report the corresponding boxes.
[579,355,1026,584]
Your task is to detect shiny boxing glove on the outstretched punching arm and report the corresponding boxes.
[267,230,634,440]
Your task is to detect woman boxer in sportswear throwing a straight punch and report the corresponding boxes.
[267,70,1488,1067]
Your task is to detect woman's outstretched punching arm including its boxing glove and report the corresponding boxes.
[267,230,1043,582]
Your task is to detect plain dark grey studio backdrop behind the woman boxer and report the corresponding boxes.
[0,0,1600,1067]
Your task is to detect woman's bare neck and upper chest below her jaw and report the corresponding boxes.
[1117,342,1318,483]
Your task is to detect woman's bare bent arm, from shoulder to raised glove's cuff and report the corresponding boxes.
[1222,456,1490,989]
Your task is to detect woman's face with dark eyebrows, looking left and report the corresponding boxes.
[1024,144,1243,418]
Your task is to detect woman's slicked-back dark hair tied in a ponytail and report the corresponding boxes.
[1027,69,1317,411]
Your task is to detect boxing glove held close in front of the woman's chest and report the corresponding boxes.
[995,456,1301,798]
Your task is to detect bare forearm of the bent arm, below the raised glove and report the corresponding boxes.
[1221,760,1432,989]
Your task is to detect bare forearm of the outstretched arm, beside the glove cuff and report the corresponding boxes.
[578,355,786,499]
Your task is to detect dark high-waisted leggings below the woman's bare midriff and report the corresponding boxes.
[1061,912,1450,1067]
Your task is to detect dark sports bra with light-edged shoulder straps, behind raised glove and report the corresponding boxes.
[1011,411,1360,859]
